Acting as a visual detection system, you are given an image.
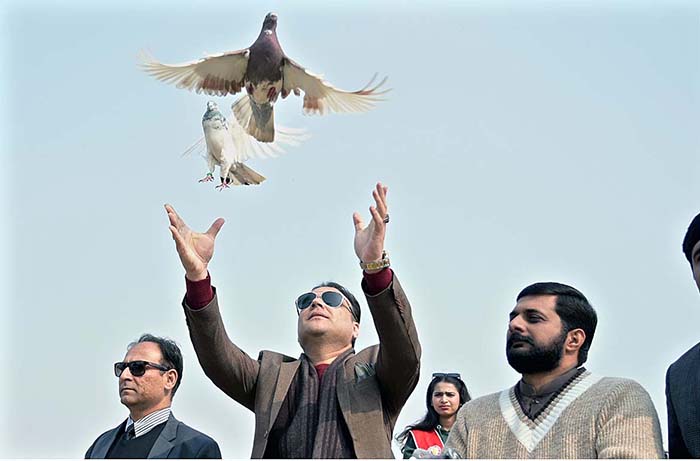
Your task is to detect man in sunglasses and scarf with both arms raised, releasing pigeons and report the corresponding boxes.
[166,184,421,458]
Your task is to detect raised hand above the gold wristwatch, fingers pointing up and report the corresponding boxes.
[352,183,389,270]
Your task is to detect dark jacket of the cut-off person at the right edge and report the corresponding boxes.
[666,343,700,458]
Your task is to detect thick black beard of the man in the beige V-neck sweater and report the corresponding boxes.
[506,330,566,374]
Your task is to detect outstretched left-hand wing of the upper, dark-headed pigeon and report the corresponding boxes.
[139,48,250,96]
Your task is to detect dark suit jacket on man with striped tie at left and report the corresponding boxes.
[85,413,221,459]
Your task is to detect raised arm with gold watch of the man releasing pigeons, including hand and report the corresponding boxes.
[353,183,421,417]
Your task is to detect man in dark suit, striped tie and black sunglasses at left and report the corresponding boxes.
[85,334,221,459]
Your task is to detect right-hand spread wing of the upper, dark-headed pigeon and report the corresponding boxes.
[282,58,389,115]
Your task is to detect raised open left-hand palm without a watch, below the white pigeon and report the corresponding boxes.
[165,204,224,282]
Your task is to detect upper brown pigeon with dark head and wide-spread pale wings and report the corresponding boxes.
[137,13,389,142]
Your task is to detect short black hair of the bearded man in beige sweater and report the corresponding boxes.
[516,282,598,366]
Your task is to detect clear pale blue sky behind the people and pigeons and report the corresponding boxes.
[0,0,700,458]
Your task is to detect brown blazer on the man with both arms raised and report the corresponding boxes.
[183,275,421,458]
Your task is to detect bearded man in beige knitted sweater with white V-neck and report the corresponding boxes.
[445,282,664,459]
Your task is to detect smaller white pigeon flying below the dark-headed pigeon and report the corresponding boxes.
[183,96,309,190]
